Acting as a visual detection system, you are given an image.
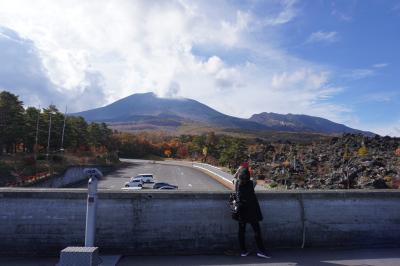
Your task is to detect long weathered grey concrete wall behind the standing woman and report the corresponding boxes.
[0,189,400,255]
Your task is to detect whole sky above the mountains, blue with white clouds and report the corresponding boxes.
[0,0,400,136]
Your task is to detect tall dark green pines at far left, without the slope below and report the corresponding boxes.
[0,91,116,154]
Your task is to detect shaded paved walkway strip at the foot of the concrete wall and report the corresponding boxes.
[0,248,400,266]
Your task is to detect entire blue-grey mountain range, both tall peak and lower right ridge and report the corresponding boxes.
[72,93,372,135]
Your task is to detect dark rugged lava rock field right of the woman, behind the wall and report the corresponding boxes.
[250,134,400,189]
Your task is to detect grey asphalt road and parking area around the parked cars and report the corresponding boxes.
[77,160,227,191]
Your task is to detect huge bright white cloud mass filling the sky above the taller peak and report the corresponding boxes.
[0,0,351,122]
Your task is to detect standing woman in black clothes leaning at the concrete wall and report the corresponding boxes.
[235,163,270,258]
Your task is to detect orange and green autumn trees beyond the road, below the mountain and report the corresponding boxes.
[114,132,249,169]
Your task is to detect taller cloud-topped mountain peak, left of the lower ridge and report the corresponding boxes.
[74,92,269,130]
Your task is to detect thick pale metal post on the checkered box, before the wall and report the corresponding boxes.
[85,173,97,247]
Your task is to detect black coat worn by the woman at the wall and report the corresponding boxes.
[237,180,263,223]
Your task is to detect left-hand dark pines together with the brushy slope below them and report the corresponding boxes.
[0,91,118,185]
